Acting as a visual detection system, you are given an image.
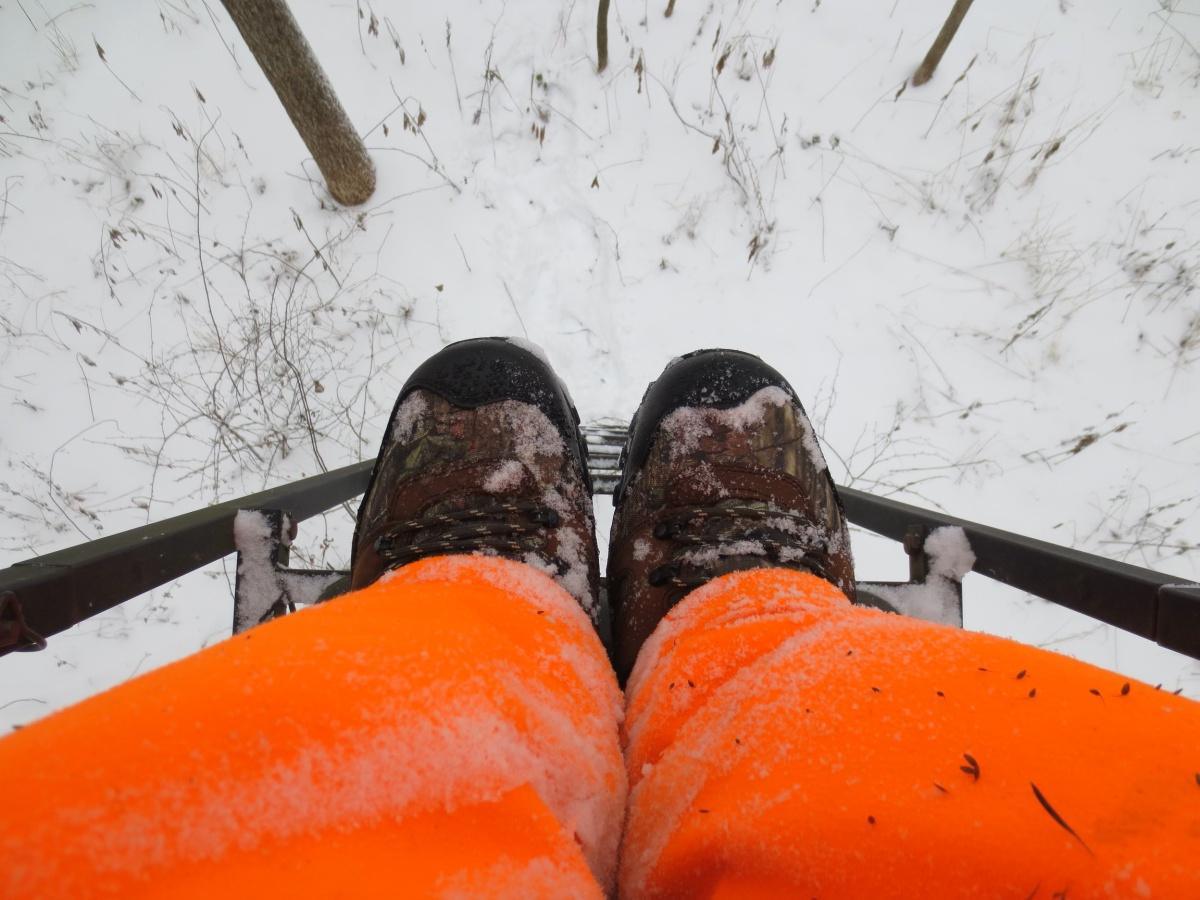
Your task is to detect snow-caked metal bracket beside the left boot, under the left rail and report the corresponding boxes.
[233,509,349,635]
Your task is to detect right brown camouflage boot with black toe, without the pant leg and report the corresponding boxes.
[608,350,854,683]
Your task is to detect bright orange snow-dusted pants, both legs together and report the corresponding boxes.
[0,557,1200,900]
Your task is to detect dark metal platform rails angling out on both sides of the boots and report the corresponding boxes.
[0,461,1200,658]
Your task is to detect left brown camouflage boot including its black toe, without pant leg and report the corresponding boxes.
[350,337,608,638]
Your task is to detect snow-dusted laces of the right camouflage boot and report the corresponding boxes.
[647,506,833,592]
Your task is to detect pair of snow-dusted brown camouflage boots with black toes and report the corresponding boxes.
[350,337,854,680]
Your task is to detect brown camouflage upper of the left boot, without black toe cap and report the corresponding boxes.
[350,347,599,620]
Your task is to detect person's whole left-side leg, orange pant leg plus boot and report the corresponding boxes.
[0,340,625,898]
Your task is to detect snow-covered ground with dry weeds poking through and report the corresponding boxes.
[0,0,1200,730]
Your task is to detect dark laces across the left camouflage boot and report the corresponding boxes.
[374,500,562,569]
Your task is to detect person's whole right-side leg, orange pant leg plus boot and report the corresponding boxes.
[610,352,1200,896]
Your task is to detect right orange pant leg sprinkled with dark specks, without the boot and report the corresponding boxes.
[619,570,1200,898]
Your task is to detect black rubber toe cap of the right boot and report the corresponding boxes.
[612,349,799,504]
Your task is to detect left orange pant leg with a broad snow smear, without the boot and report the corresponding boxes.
[0,557,625,900]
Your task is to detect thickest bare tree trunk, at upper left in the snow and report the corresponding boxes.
[222,0,374,206]
